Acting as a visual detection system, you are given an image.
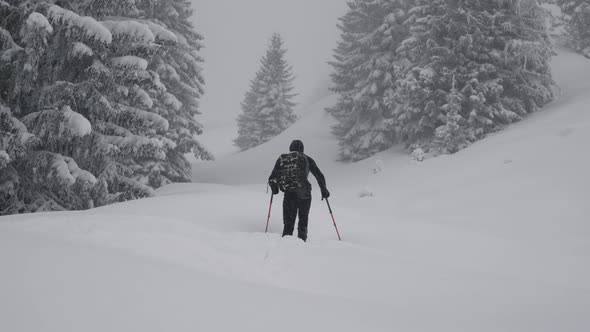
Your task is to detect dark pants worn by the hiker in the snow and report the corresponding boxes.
[283,192,311,241]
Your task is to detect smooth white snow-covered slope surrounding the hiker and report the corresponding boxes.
[0,51,590,332]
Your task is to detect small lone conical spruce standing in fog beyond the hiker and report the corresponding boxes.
[234,34,296,150]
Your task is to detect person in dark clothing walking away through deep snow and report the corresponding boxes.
[268,140,330,241]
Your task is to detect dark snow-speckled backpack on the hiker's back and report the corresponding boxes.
[278,151,309,192]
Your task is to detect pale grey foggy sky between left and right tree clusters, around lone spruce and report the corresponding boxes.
[193,0,346,130]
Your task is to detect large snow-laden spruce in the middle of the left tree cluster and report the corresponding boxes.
[40,5,170,205]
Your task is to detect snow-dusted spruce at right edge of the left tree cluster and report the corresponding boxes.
[78,0,213,187]
